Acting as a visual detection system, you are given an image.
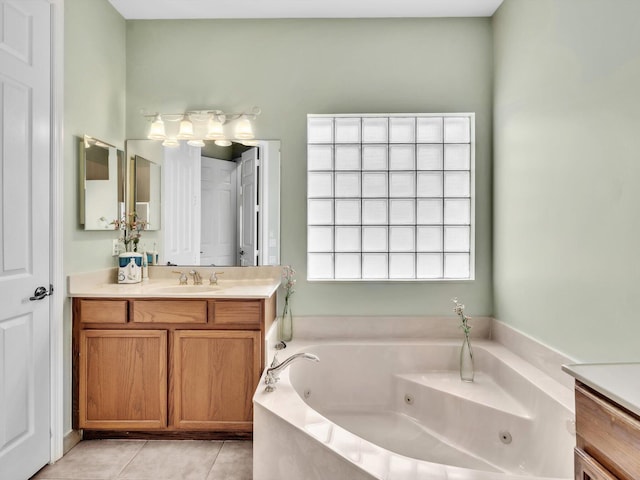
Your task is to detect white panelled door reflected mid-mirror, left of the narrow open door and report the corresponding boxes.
[200,157,238,266]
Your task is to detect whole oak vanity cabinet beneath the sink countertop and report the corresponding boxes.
[73,295,275,438]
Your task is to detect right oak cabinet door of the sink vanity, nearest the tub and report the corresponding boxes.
[169,330,261,432]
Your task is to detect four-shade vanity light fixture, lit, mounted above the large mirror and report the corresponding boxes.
[143,107,261,147]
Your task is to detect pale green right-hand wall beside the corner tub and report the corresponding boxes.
[493,0,640,361]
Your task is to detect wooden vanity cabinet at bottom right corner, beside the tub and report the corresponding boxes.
[575,382,640,480]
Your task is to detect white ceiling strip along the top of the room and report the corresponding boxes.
[109,0,503,20]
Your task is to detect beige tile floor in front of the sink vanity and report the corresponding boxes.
[31,440,253,480]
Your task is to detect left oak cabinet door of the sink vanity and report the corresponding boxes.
[78,330,167,430]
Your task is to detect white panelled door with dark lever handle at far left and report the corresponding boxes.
[0,0,51,480]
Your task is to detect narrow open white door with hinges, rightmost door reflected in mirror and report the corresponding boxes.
[239,148,259,267]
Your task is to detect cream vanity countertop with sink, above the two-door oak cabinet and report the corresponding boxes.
[67,267,281,298]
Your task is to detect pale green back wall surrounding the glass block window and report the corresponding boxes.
[126,18,492,315]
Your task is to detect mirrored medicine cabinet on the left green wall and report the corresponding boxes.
[78,135,126,230]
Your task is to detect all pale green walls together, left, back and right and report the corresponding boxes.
[64,0,640,438]
